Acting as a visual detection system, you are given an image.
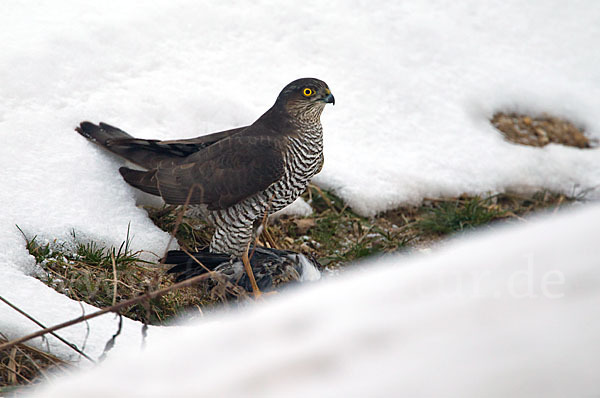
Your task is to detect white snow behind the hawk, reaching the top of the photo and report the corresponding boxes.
[0,0,600,394]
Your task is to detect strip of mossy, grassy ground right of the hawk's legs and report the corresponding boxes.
[264,188,574,269]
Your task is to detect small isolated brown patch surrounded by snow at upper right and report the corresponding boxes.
[491,112,597,148]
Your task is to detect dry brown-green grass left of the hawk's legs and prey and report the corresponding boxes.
[26,227,207,324]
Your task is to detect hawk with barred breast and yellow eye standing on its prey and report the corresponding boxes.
[76,78,335,292]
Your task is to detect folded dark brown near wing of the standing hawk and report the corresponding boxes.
[120,136,284,210]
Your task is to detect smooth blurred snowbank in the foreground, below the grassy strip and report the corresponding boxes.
[30,205,600,398]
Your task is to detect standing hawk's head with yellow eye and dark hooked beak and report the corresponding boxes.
[275,78,335,122]
